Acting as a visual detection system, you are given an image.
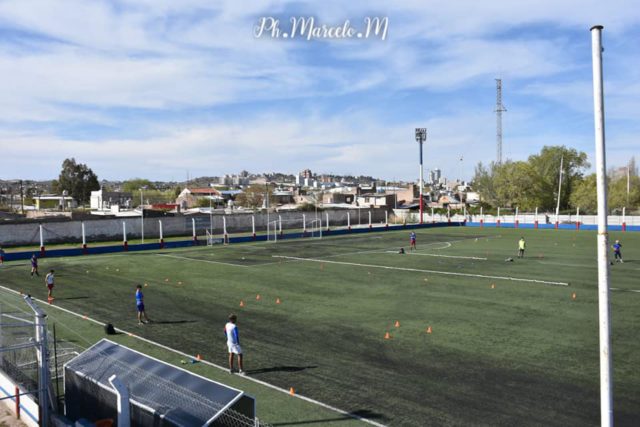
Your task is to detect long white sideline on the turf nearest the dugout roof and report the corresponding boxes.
[0,285,386,427]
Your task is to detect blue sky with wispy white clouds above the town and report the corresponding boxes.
[0,0,640,180]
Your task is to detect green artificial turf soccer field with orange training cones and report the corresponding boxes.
[0,227,640,426]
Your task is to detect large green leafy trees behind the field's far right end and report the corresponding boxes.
[472,146,640,213]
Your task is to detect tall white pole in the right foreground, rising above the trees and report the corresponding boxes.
[591,25,613,427]
